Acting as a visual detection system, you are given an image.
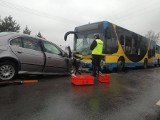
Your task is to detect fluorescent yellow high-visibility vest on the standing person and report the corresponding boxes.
[92,39,103,55]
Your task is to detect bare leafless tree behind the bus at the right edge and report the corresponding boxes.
[145,30,160,43]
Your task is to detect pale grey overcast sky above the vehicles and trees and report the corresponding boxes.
[0,0,160,46]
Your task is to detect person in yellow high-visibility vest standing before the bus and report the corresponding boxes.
[90,34,103,77]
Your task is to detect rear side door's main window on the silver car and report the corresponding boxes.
[22,37,41,51]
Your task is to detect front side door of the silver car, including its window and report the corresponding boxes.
[43,41,68,73]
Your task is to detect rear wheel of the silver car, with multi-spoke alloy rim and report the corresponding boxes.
[0,62,17,80]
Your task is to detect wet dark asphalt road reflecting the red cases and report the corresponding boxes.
[0,68,160,120]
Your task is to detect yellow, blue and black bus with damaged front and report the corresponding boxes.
[64,21,160,70]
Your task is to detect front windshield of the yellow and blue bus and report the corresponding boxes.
[75,34,94,55]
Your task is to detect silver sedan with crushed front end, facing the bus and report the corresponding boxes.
[0,32,71,80]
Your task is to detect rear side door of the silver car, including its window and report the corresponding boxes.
[10,37,45,72]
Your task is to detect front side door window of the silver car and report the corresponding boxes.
[43,41,61,55]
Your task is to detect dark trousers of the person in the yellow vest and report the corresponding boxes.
[92,55,102,76]
